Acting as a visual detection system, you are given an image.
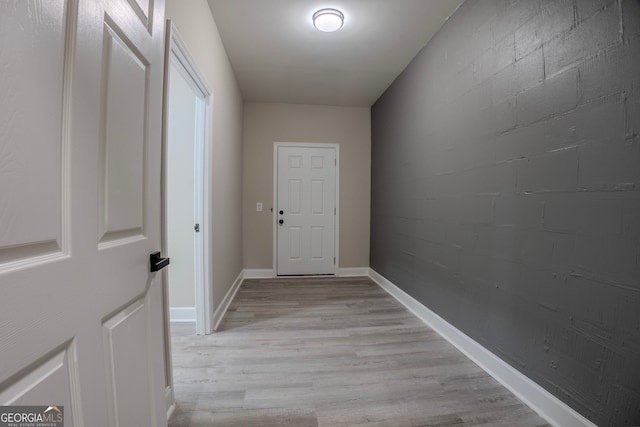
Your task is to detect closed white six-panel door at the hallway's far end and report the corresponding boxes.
[274,145,337,275]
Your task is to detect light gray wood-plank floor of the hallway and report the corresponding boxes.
[169,278,547,427]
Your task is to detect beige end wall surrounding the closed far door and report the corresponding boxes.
[242,102,371,269]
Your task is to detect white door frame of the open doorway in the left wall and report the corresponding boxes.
[161,19,214,412]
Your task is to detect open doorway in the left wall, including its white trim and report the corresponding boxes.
[163,21,213,335]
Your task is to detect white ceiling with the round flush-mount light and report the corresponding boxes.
[208,0,462,107]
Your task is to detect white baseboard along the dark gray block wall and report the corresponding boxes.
[369,268,596,427]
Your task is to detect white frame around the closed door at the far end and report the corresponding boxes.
[271,142,340,277]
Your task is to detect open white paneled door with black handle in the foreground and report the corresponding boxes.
[0,0,166,427]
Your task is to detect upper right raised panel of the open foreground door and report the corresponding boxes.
[98,21,149,246]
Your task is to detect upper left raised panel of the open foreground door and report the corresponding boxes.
[0,0,77,273]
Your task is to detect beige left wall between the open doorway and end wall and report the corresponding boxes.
[166,0,243,310]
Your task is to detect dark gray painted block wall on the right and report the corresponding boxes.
[371,0,640,426]
